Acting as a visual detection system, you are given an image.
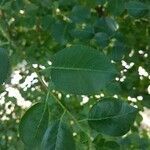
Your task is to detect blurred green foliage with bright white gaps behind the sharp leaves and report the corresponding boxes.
[0,0,150,150]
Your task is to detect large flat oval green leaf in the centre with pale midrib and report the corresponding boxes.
[51,45,116,94]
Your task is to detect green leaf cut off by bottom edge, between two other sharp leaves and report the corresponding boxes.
[42,120,75,150]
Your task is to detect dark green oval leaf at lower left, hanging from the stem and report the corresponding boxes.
[19,103,49,148]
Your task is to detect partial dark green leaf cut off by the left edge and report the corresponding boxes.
[0,48,10,84]
